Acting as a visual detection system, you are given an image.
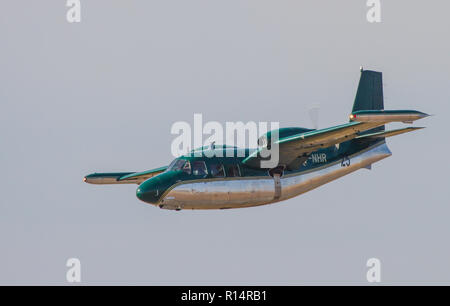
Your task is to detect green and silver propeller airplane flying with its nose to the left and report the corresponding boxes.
[84,67,429,211]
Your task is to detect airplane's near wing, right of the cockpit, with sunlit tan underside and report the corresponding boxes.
[243,121,387,169]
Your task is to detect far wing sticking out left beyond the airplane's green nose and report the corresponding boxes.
[83,166,167,184]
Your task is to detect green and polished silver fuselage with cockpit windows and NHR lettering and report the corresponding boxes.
[137,139,391,210]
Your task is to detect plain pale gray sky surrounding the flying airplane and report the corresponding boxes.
[0,0,450,285]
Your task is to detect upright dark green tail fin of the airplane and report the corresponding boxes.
[352,67,384,132]
